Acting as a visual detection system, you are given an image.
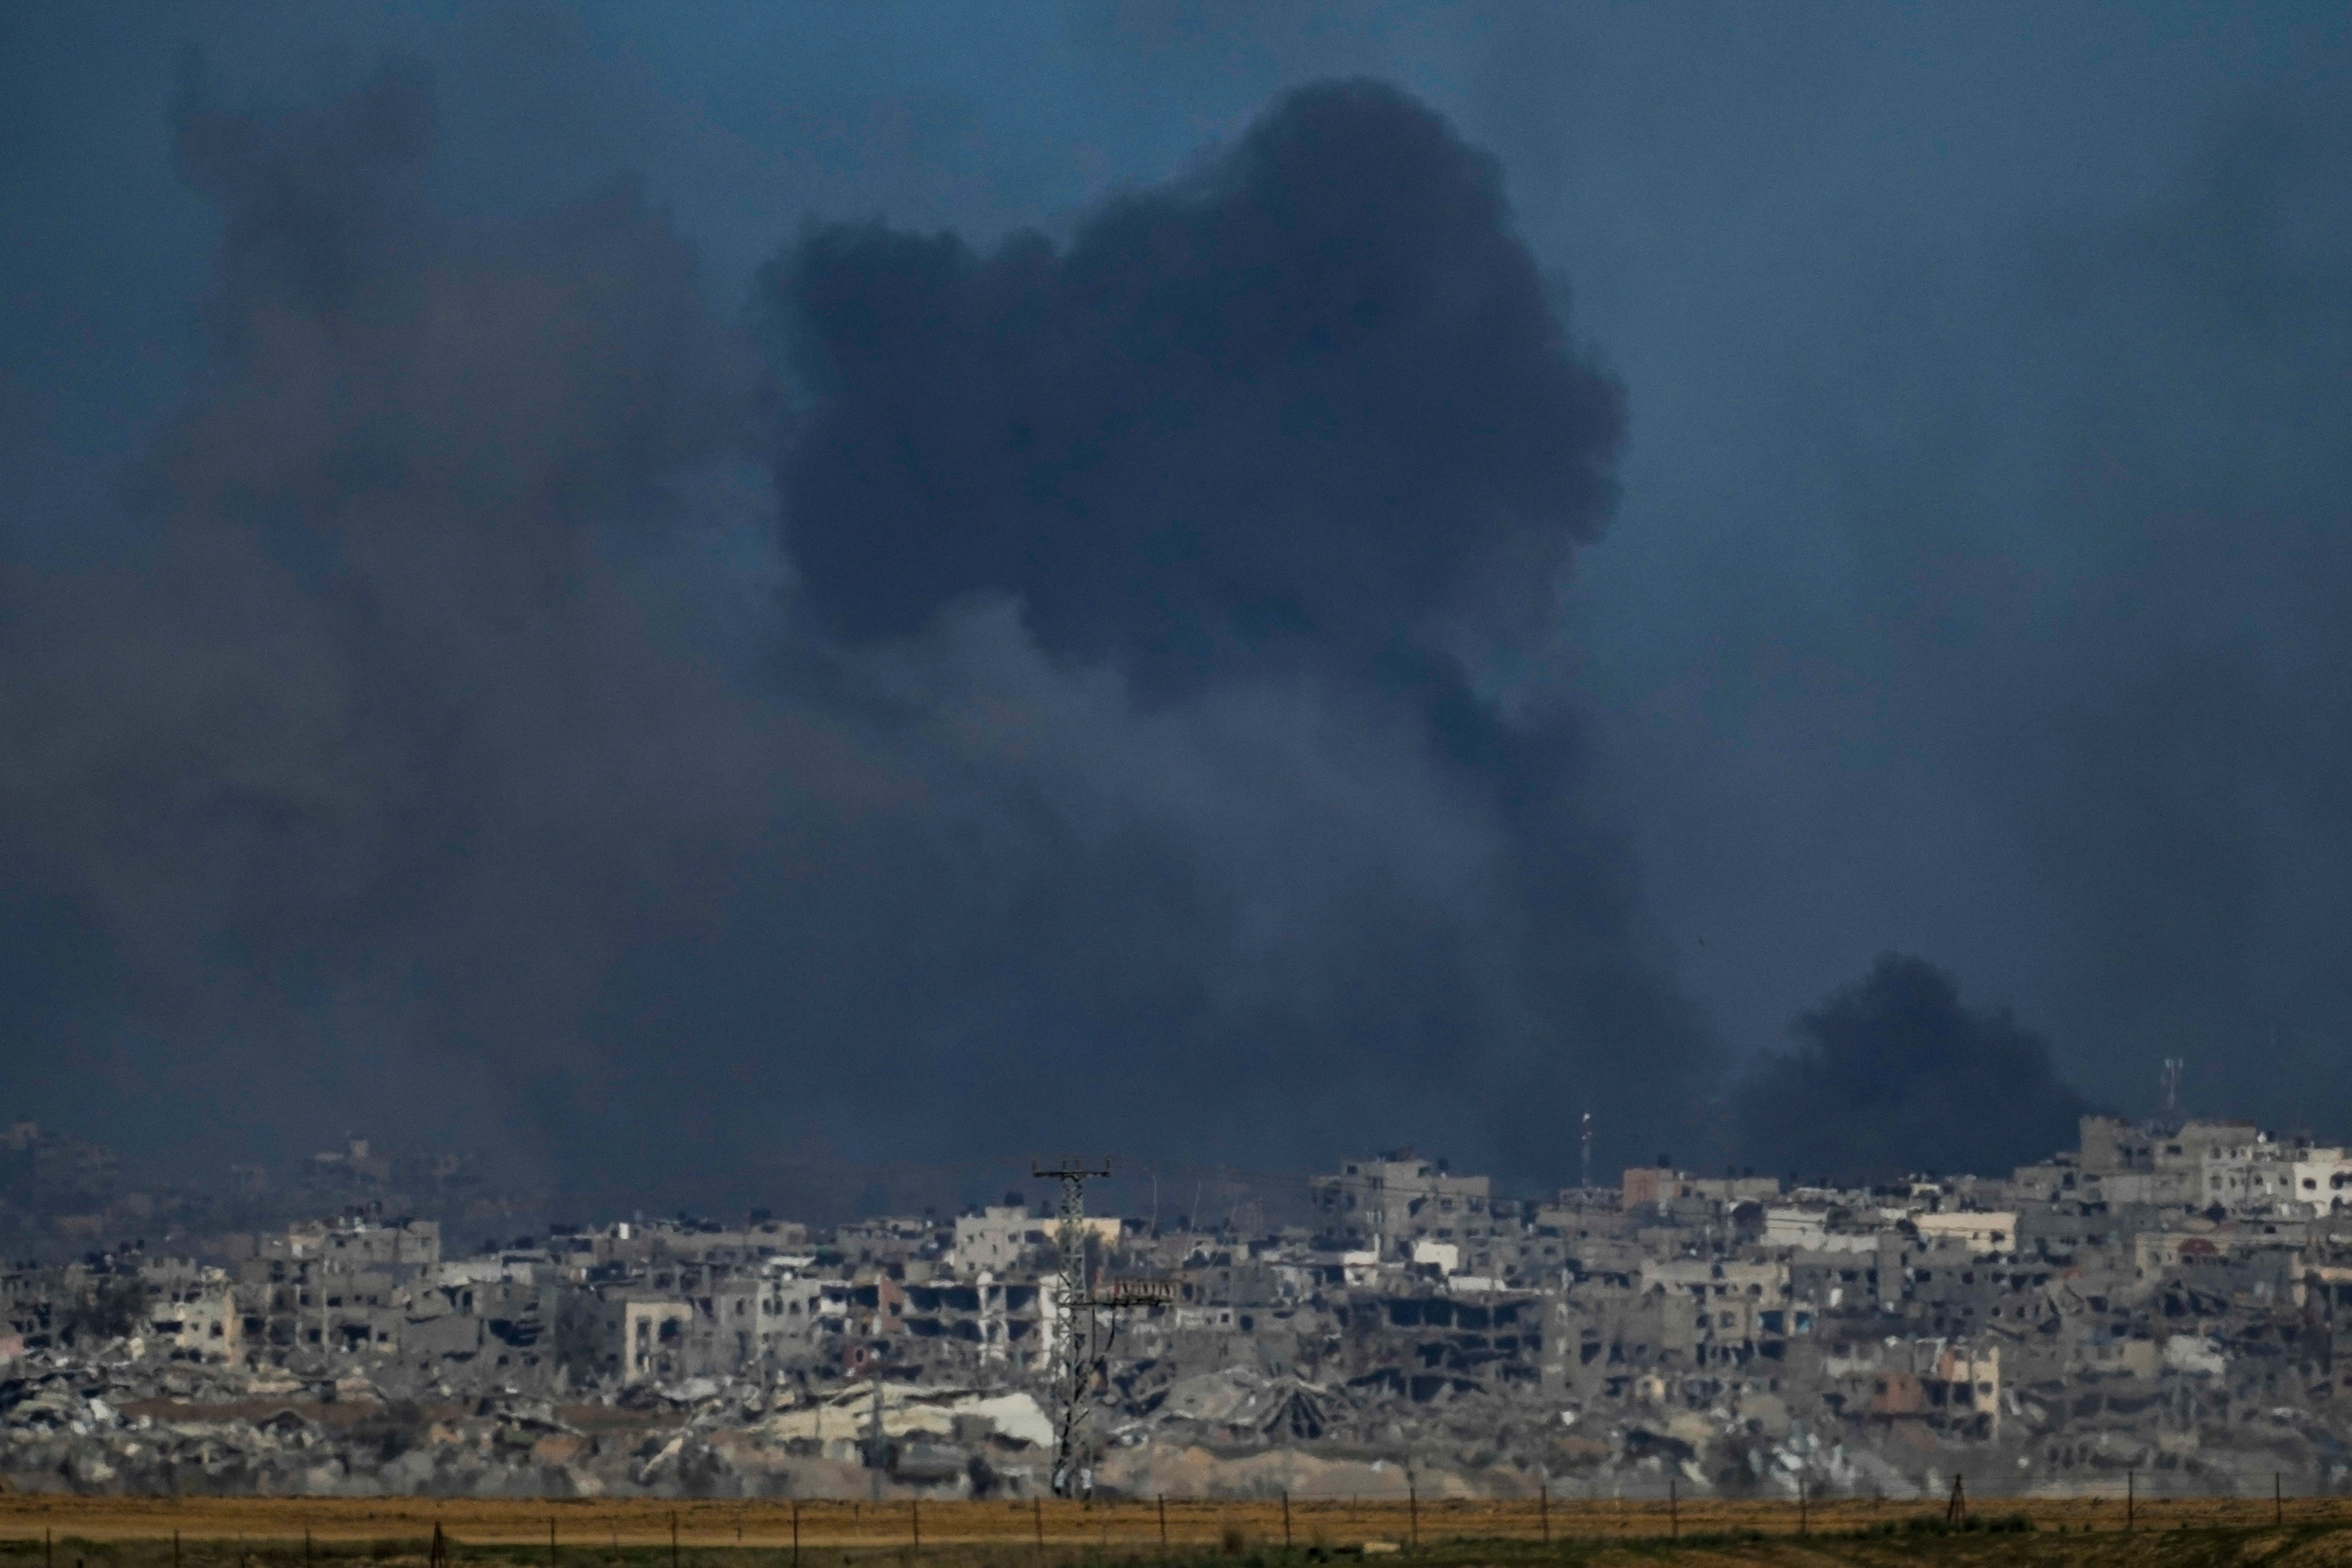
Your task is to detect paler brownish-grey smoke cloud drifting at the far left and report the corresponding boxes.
[0,67,755,1175]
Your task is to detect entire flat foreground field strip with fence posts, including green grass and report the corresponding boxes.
[14,1495,2352,1568]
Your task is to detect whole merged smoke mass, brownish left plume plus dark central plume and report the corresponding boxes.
[0,75,1705,1206]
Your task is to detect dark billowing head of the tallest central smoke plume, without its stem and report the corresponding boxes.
[776,82,1625,694]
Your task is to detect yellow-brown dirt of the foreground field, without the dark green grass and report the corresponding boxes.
[14,1493,2352,1568]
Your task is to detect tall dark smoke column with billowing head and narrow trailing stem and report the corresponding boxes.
[769,82,1703,1173]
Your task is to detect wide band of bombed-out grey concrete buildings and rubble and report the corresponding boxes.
[14,1117,2352,1497]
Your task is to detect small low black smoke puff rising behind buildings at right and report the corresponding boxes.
[1738,954,2091,1180]
